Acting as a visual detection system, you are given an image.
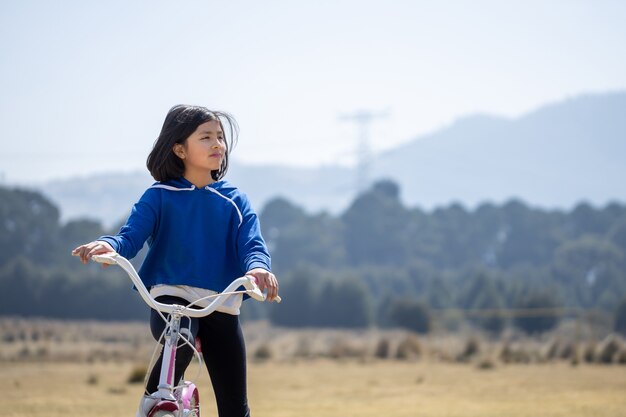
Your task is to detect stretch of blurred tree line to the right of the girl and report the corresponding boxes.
[261,181,626,332]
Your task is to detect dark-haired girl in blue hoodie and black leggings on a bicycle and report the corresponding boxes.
[73,105,278,417]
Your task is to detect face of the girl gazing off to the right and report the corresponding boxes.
[173,120,226,178]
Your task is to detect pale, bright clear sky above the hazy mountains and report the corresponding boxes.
[0,0,626,184]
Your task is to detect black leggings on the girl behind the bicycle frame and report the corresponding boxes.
[146,296,250,417]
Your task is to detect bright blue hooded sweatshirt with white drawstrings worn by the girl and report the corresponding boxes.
[98,177,271,292]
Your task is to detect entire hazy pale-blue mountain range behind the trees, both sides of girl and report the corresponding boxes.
[38,92,626,225]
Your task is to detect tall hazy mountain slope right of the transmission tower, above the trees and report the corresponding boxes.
[374,92,626,208]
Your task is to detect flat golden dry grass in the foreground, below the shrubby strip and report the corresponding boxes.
[0,359,626,417]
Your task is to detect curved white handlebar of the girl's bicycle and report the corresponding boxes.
[91,253,281,317]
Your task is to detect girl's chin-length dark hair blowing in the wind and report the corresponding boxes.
[146,104,239,181]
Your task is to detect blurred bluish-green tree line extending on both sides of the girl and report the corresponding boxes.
[0,180,626,333]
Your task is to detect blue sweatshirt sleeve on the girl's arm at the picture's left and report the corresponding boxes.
[98,189,159,259]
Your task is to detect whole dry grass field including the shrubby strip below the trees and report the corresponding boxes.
[0,319,626,417]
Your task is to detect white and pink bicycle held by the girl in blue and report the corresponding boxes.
[87,253,281,417]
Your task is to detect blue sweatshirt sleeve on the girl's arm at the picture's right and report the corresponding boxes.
[237,194,272,271]
